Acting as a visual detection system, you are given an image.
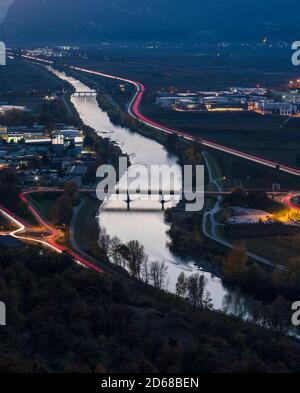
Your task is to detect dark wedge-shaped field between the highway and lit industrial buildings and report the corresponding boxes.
[143,105,300,166]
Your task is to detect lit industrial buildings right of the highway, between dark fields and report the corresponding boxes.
[156,86,300,116]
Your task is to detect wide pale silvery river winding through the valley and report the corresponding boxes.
[51,69,251,315]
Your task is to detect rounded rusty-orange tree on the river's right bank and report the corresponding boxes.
[223,244,247,283]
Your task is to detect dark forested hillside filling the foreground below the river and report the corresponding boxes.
[0,247,300,373]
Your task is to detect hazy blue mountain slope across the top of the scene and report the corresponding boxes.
[0,0,300,43]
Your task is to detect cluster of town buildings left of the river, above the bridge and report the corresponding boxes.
[0,124,99,186]
